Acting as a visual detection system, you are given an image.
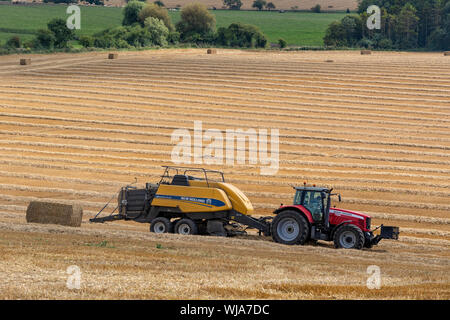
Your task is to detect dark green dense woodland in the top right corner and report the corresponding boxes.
[324,0,450,50]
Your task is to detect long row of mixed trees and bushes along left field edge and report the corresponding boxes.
[0,0,267,52]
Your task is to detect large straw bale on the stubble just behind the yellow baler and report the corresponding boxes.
[26,201,83,227]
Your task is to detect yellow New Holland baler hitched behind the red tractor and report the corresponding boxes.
[91,166,269,235]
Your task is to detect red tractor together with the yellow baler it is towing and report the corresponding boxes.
[90,166,399,249]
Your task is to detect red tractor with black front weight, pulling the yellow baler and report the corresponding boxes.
[270,185,399,249]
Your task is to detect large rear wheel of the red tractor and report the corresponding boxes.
[271,210,309,245]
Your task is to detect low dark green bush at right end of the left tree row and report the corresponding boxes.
[217,23,267,48]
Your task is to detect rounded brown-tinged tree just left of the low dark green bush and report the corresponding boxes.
[176,2,216,39]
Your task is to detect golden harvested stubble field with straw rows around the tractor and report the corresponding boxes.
[0,49,450,299]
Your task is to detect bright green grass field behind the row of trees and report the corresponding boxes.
[0,5,345,46]
